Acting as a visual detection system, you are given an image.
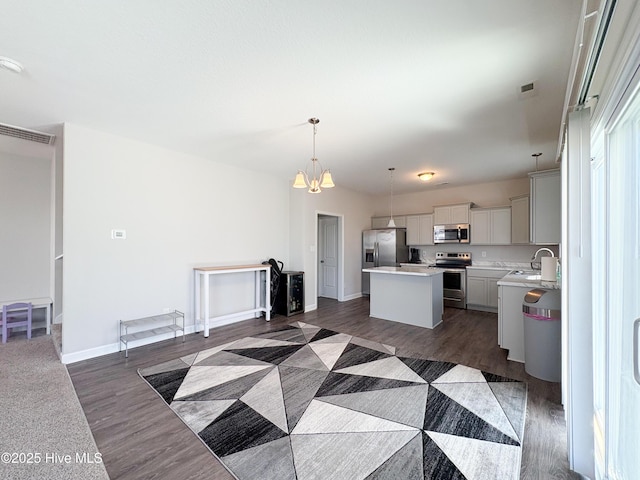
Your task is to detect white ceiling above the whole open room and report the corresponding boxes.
[0,0,583,195]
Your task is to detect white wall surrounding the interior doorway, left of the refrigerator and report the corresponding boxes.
[285,187,373,310]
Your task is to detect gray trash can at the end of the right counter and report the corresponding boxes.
[522,288,562,382]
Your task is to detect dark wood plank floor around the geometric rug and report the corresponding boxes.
[68,298,579,480]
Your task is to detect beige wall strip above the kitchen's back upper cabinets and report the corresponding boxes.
[373,177,529,216]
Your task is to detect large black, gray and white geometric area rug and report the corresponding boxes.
[139,322,527,480]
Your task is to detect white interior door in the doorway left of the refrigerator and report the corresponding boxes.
[318,215,338,299]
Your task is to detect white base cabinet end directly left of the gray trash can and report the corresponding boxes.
[498,285,531,363]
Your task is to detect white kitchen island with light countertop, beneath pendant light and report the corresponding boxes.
[362,266,443,328]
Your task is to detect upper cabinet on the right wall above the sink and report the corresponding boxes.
[529,169,562,245]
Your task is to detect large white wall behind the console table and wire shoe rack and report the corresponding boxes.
[62,124,289,361]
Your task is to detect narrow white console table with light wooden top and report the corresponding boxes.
[193,263,271,337]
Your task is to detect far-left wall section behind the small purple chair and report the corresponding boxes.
[0,152,52,300]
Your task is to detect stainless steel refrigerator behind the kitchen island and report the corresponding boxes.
[362,228,409,295]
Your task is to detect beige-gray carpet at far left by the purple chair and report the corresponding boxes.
[0,332,109,480]
